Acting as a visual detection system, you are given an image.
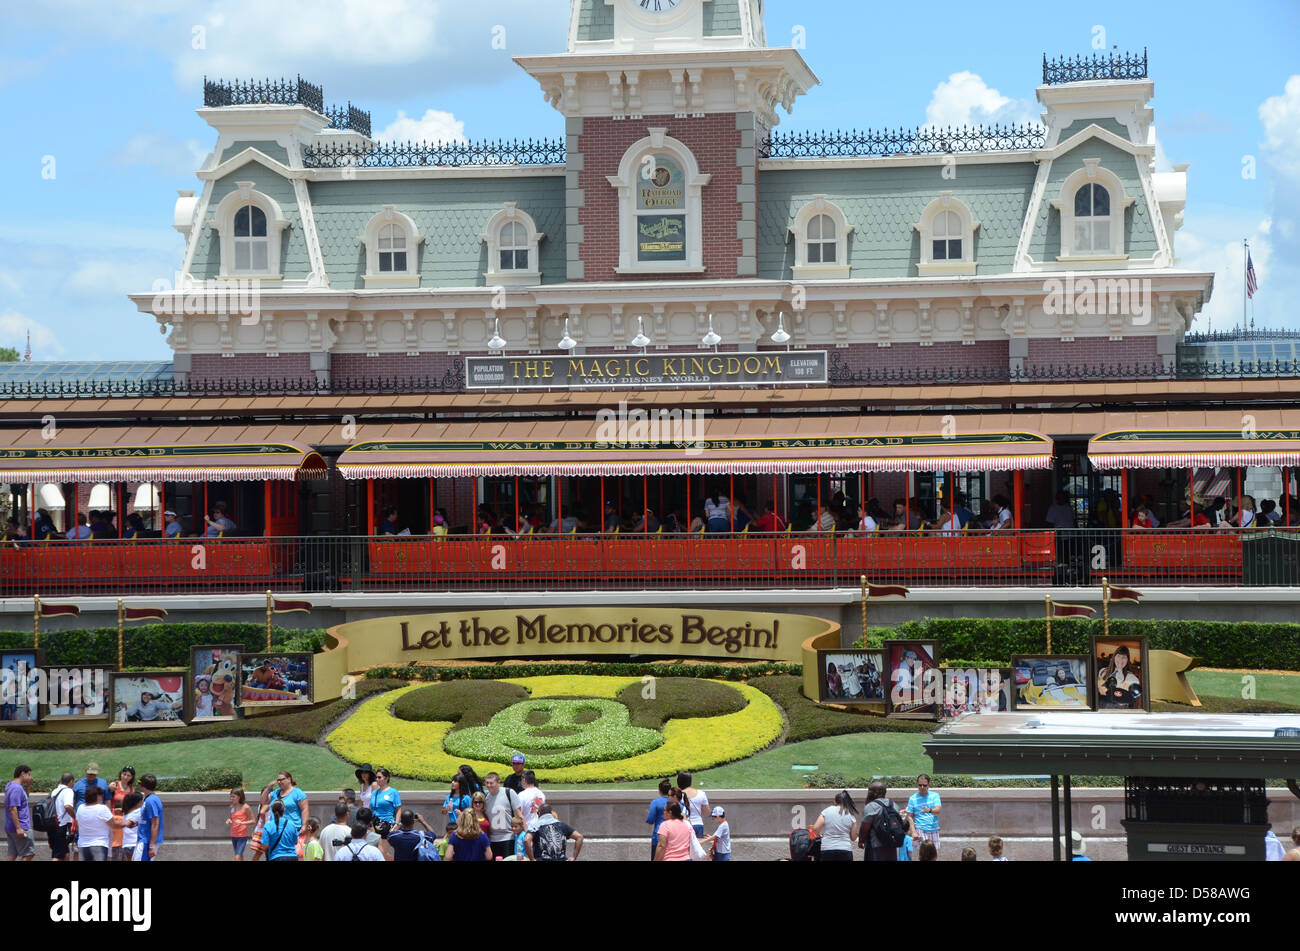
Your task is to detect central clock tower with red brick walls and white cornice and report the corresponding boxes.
[515,0,818,282]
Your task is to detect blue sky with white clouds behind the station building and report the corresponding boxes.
[0,0,1300,360]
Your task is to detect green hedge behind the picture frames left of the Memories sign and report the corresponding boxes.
[0,621,326,670]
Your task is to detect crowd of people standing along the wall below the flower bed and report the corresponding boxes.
[4,754,1300,861]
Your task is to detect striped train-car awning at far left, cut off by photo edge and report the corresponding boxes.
[0,421,326,482]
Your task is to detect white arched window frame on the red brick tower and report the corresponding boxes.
[605,129,712,274]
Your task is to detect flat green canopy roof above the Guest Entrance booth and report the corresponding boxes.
[923,711,1300,780]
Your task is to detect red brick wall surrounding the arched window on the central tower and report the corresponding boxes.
[579,113,741,281]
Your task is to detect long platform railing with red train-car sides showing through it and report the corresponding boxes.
[0,529,1300,598]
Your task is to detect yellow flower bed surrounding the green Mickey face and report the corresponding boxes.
[326,677,783,782]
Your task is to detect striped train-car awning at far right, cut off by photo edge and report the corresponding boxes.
[1088,426,1300,469]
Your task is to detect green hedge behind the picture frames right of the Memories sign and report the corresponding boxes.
[867,617,1300,670]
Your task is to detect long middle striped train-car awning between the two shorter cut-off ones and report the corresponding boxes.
[338,413,1052,479]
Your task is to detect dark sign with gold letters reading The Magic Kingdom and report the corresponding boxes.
[465,349,827,390]
